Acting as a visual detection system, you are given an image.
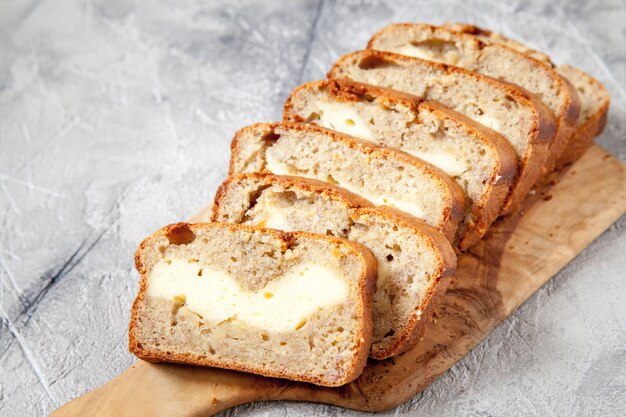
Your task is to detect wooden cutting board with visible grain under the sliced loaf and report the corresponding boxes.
[52,146,626,417]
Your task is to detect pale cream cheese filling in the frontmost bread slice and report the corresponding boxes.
[147,259,349,332]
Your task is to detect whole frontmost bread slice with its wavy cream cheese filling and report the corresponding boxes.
[129,223,377,386]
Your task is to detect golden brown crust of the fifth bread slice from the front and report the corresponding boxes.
[328,49,555,214]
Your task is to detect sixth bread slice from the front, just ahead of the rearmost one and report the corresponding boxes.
[367,23,580,175]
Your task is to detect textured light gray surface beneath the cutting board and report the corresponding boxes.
[0,0,626,416]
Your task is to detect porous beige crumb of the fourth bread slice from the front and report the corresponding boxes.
[285,80,499,202]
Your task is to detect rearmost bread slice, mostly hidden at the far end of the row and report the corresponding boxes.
[445,23,611,168]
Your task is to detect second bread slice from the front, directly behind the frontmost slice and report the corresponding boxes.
[213,174,456,359]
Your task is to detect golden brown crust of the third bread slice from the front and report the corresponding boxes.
[230,123,466,241]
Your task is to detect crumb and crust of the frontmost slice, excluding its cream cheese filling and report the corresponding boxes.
[129,223,376,386]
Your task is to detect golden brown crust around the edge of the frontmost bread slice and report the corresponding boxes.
[128,222,377,386]
